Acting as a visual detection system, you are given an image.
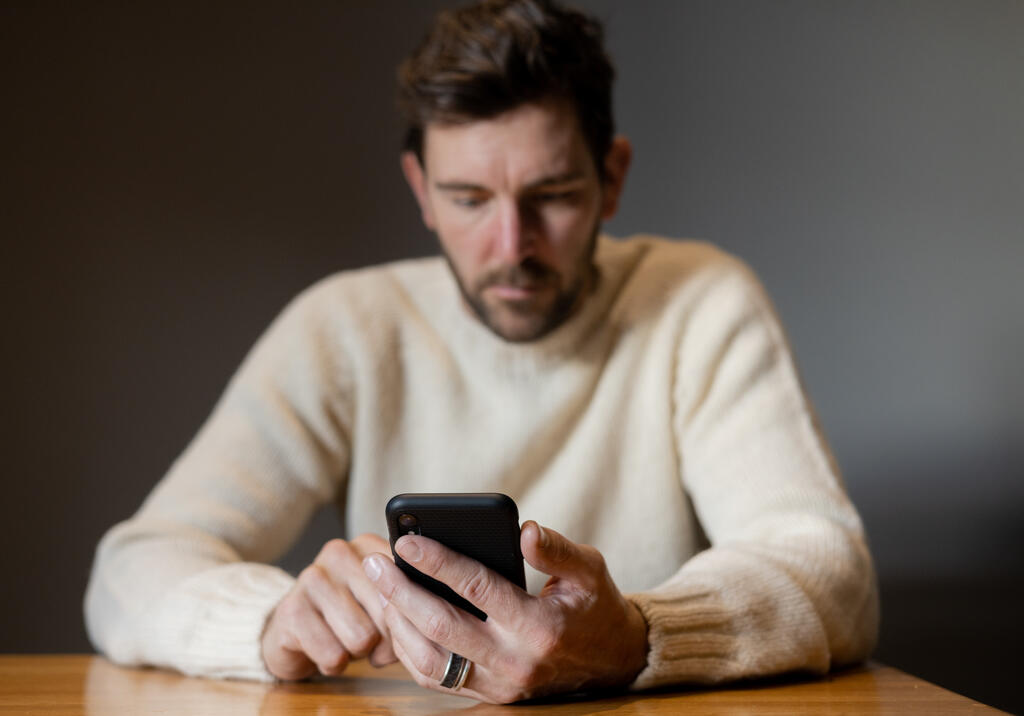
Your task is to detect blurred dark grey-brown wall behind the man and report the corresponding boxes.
[0,0,1024,711]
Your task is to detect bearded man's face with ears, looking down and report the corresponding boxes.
[402,102,628,341]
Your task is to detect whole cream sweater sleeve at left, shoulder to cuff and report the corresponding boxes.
[85,276,350,680]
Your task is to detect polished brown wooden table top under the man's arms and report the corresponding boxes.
[0,655,999,716]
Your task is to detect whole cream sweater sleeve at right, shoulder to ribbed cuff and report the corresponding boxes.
[629,260,879,688]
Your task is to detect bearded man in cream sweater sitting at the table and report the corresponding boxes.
[86,0,878,702]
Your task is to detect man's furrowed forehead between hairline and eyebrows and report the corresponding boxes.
[423,102,593,184]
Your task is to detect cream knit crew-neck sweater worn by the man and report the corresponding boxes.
[85,237,878,688]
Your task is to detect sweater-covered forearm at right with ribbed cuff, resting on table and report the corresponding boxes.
[628,516,879,688]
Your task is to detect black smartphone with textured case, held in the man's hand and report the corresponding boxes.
[384,493,526,621]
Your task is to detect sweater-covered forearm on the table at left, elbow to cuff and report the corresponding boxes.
[85,523,293,680]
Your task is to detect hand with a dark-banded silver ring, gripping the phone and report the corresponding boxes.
[364,521,647,704]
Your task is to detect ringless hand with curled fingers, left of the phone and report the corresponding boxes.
[261,535,397,680]
